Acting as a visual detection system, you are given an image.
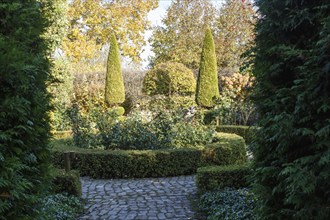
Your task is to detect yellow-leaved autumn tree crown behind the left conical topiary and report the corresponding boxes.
[63,0,158,61]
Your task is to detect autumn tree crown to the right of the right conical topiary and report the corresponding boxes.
[214,0,256,75]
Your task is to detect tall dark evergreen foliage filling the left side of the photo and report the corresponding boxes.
[0,0,50,219]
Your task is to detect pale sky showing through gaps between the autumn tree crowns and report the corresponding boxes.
[141,0,223,69]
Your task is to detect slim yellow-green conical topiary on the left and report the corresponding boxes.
[104,34,125,106]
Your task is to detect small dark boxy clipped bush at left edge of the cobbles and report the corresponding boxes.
[52,170,81,196]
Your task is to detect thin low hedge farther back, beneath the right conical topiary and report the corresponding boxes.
[216,125,258,144]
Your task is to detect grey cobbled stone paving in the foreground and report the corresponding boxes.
[78,176,197,220]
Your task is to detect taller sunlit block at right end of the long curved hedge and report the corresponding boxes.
[202,133,247,165]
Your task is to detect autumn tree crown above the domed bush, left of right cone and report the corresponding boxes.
[150,0,215,69]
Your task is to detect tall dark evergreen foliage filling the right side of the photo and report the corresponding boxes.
[253,0,330,220]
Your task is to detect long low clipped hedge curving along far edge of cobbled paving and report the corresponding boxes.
[53,133,246,178]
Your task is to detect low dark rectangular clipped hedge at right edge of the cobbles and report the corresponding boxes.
[196,164,251,193]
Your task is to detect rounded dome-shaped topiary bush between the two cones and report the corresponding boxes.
[143,62,196,95]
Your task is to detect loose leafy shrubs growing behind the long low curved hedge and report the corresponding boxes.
[100,112,214,150]
